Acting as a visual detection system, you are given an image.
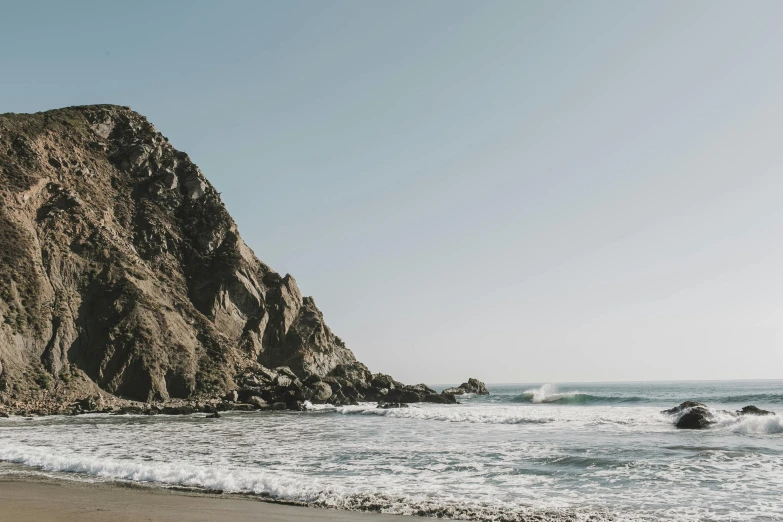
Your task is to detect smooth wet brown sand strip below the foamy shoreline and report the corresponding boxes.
[0,475,410,522]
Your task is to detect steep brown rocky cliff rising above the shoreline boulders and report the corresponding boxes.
[0,105,358,401]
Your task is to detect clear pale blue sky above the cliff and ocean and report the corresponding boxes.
[0,0,783,384]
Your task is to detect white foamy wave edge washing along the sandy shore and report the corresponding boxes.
[0,447,624,522]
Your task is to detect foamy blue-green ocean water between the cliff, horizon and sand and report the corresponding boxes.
[0,381,783,521]
